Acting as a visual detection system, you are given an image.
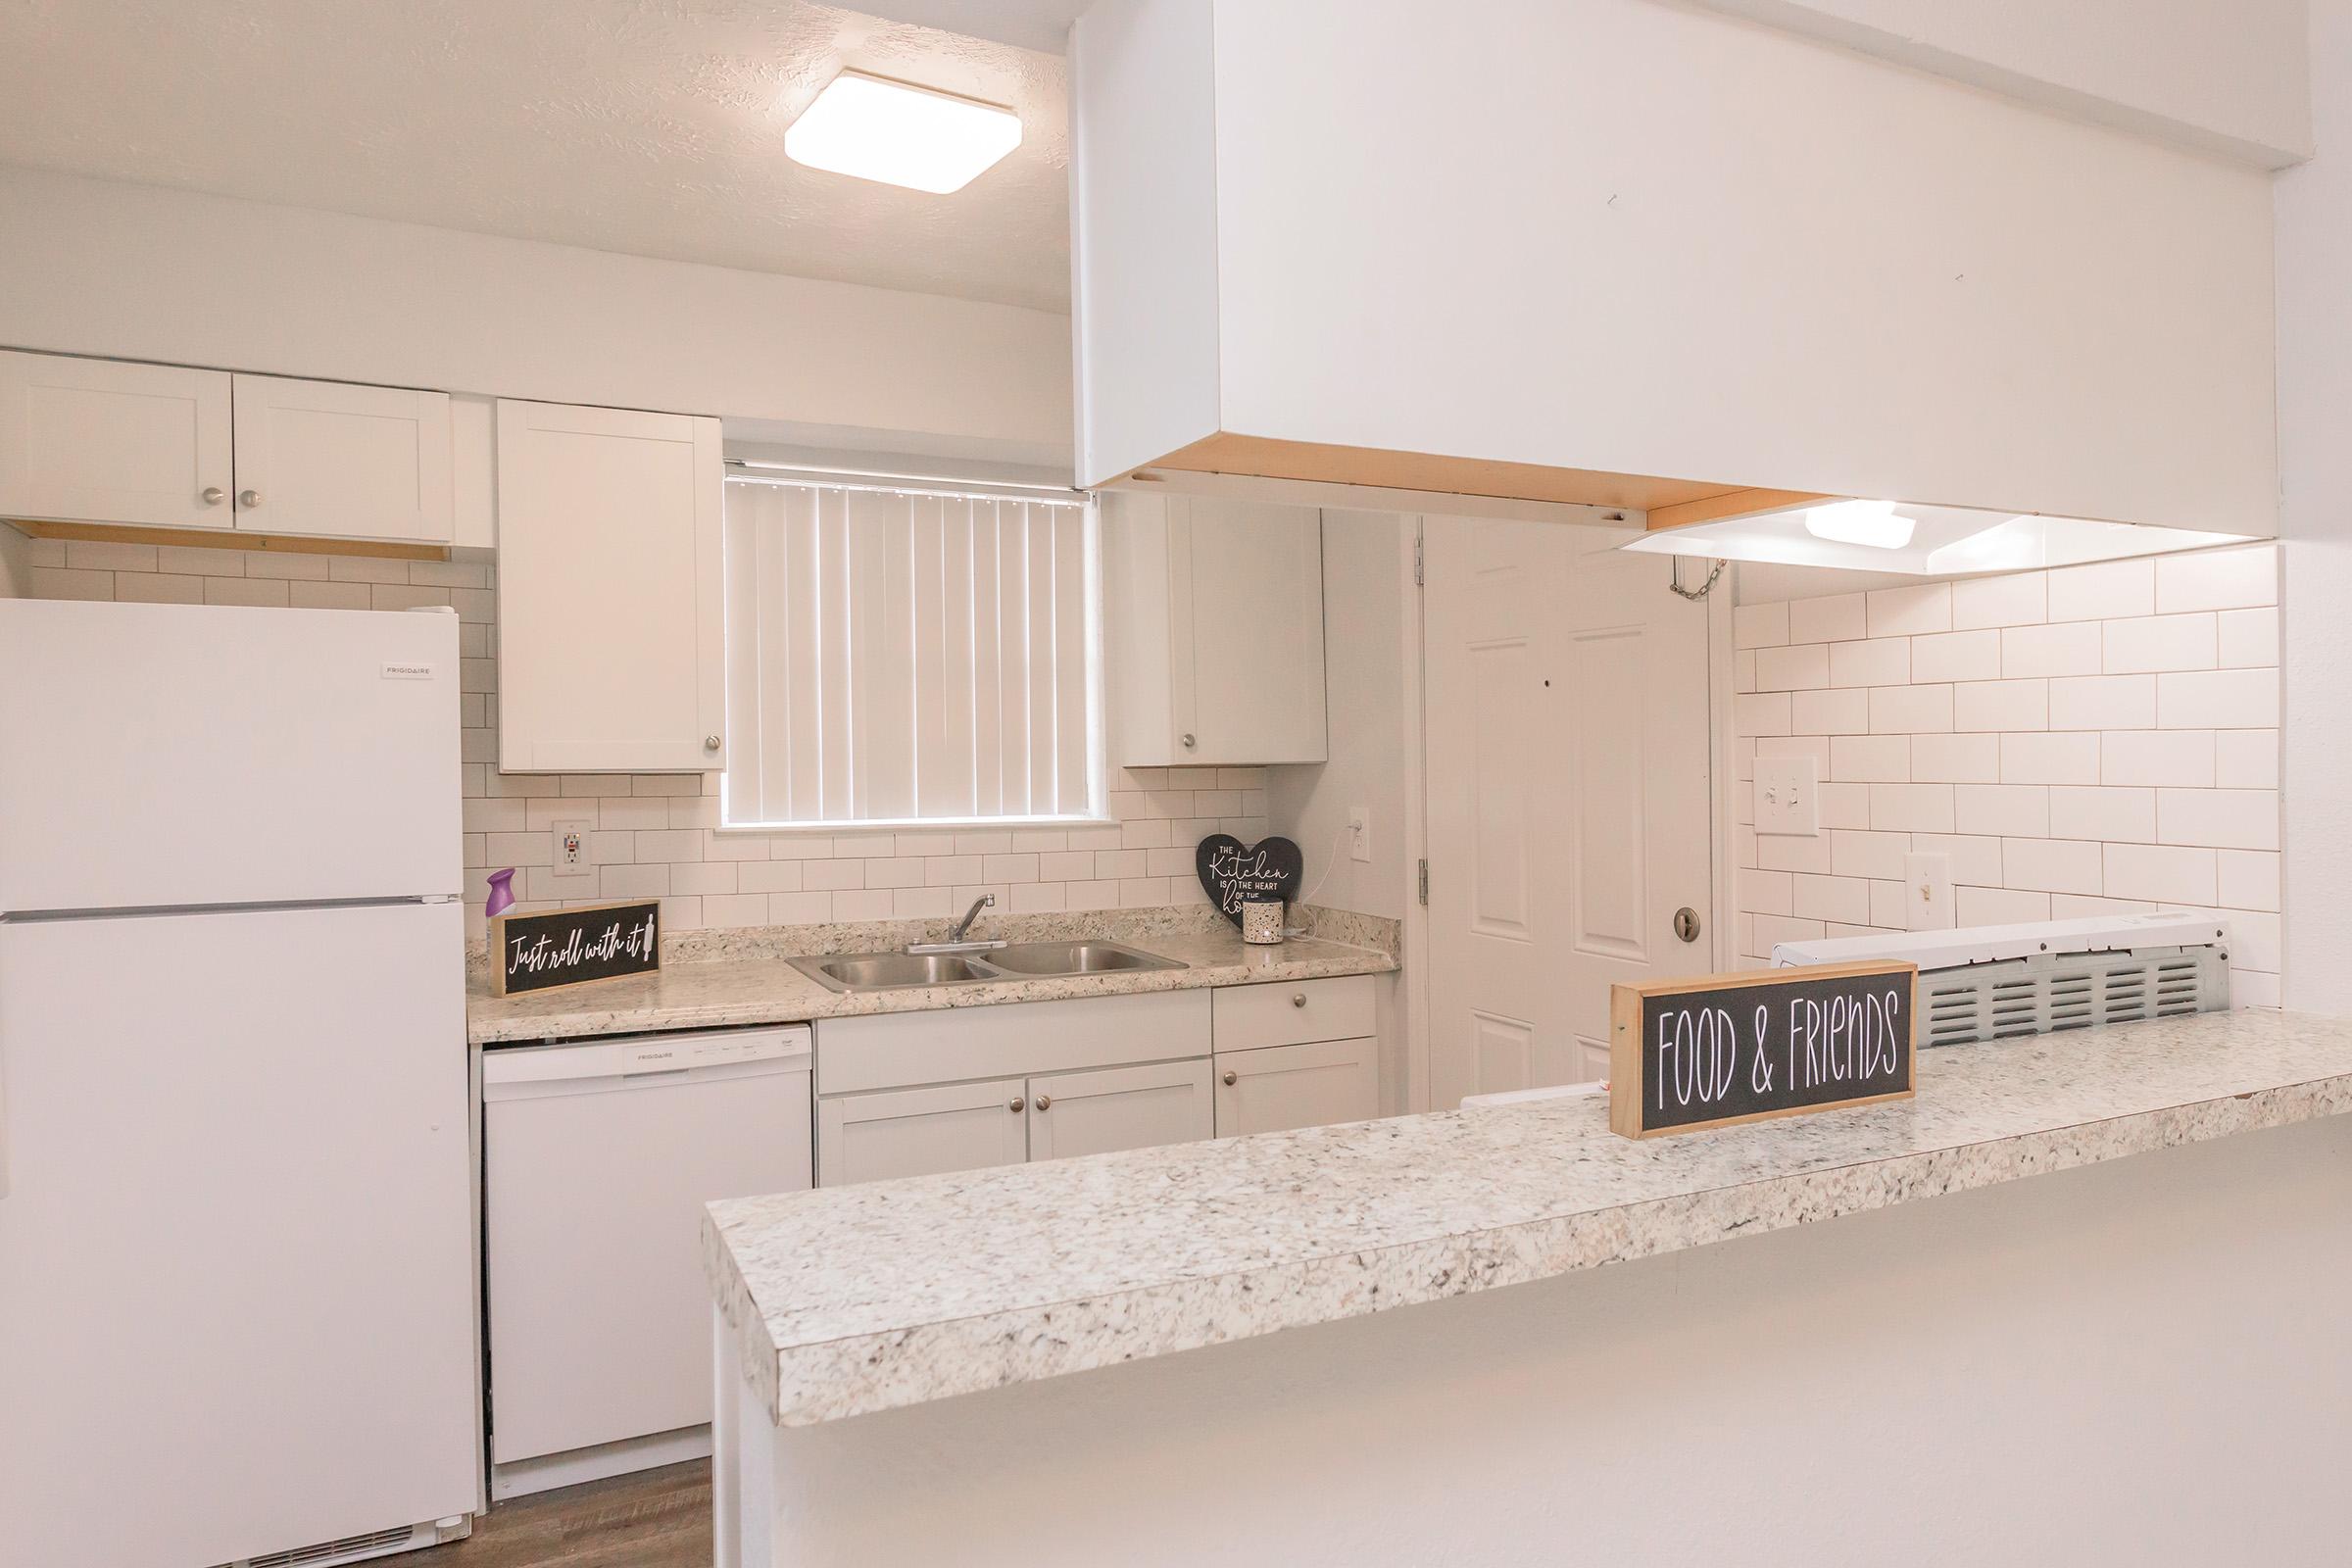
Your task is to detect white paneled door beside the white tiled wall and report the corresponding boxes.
[1423,517,1712,1107]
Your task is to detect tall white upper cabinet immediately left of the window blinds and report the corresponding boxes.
[499,400,724,773]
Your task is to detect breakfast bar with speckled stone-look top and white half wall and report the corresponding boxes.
[706,1010,2352,1563]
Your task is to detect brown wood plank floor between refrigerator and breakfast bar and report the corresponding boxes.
[425,1460,710,1568]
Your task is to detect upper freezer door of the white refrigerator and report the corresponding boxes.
[0,600,464,914]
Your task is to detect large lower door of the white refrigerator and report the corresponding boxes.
[0,893,480,1568]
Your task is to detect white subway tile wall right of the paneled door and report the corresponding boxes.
[1734,546,2281,1006]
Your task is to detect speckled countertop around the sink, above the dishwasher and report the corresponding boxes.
[466,912,1397,1046]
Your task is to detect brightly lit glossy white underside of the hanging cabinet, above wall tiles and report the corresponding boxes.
[1621,499,2251,576]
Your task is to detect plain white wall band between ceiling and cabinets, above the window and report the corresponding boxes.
[0,172,1070,470]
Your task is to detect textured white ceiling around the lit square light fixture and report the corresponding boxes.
[0,0,1070,311]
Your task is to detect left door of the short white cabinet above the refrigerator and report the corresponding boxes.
[0,353,235,529]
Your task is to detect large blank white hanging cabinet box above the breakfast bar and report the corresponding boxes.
[1075,0,2277,536]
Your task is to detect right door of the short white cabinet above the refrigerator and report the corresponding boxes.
[230,376,454,546]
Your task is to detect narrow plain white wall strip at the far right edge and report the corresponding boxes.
[2277,0,2352,1013]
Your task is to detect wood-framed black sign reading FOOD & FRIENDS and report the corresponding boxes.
[1609,961,1919,1138]
